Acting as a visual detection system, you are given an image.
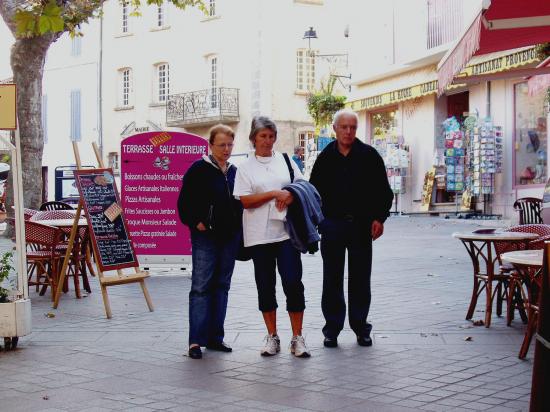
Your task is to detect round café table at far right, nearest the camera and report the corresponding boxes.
[500,249,544,359]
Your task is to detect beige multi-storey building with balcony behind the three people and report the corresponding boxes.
[102,0,349,166]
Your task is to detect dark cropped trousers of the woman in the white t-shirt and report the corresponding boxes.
[250,240,306,312]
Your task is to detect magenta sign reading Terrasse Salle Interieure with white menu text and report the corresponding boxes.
[120,132,208,264]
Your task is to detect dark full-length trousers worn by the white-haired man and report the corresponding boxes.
[321,218,372,338]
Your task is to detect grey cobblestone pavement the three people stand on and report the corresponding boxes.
[0,217,533,412]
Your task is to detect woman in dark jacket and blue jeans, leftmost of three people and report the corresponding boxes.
[178,124,242,359]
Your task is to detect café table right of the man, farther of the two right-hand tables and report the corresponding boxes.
[452,229,539,328]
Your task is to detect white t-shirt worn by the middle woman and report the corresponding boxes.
[233,152,304,246]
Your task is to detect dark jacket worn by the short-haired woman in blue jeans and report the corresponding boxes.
[178,158,243,238]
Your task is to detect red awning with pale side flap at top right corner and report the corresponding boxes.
[437,0,550,94]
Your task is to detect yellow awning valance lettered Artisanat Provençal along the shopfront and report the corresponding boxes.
[346,48,539,111]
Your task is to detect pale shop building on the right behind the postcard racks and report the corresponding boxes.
[349,0,548,218]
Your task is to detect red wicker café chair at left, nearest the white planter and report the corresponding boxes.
[25,221,63,300]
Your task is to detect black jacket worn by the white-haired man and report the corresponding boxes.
[309,138,393,225]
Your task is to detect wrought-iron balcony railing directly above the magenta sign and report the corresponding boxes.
[166,87,239,127]
